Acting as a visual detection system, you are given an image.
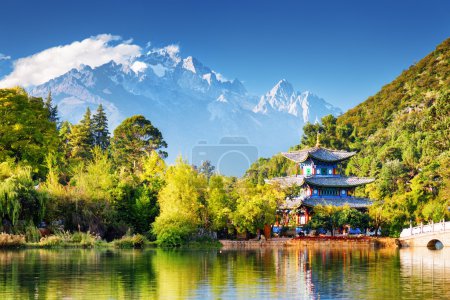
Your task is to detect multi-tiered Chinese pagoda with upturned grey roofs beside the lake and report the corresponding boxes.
[266,138,374,225]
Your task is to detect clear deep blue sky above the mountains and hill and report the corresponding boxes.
[0,0,450,109]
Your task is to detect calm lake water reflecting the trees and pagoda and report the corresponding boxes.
[0,248,450,300]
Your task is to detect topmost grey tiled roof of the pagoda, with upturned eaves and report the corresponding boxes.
[281,147,356,163]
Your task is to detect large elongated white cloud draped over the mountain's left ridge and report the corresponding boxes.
[0,34,141,87]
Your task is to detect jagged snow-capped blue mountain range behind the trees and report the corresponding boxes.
[29,46,341,175]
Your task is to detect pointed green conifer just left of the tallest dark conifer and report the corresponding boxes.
[69,107,94,159]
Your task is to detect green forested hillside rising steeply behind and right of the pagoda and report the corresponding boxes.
[247,39,450,234]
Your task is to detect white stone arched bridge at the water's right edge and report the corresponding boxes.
[398,221,450,248]
